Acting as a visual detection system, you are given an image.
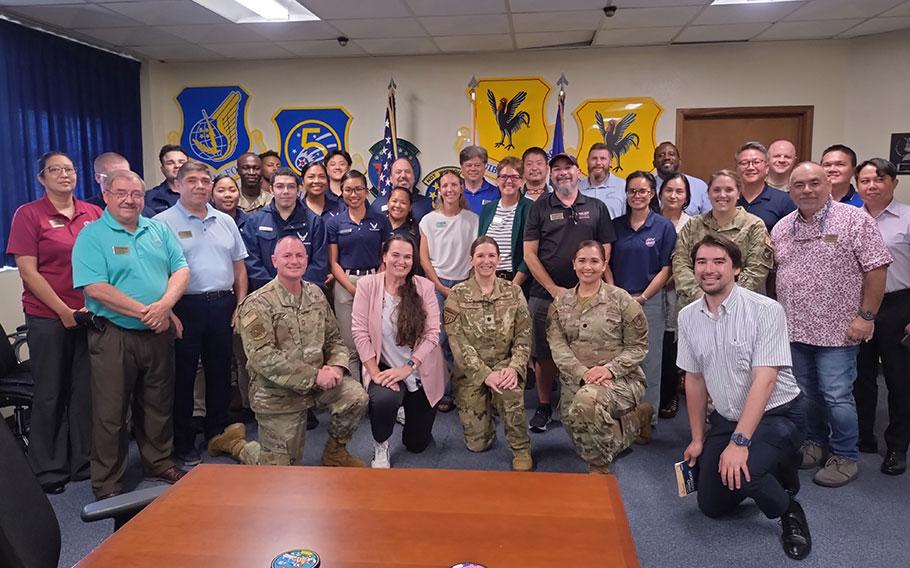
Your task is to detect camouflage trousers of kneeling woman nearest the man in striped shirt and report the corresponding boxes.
[559,380,645,467]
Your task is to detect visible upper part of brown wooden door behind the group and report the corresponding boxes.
[676,106,815,180]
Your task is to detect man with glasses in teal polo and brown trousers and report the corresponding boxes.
[73,171,190,499]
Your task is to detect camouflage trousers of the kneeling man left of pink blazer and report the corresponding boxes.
[240,375,369,465]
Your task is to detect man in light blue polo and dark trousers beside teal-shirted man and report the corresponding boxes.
[155,162,247,466]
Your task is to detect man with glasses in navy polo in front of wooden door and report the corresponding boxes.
[736,142,796,232]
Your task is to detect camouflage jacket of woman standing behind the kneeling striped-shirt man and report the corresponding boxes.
[673,207,774,310]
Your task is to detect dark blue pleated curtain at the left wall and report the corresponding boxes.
[0,20,142,266]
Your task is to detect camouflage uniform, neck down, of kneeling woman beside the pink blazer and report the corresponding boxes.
[443,278,534,471]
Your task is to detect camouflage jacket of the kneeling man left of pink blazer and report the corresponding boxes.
[237,278,348,414]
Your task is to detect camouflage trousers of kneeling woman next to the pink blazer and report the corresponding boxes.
[454,375,531,452]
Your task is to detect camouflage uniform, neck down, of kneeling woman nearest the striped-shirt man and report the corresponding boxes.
[547,283,654,473]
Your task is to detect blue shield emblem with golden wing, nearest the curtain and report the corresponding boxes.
[177,85,250,170]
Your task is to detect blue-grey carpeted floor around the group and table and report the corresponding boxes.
[51,389,910,568]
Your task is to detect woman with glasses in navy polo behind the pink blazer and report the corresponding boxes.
[326,170,392,381]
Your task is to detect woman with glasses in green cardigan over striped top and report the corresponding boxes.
[480,156,533,286]
